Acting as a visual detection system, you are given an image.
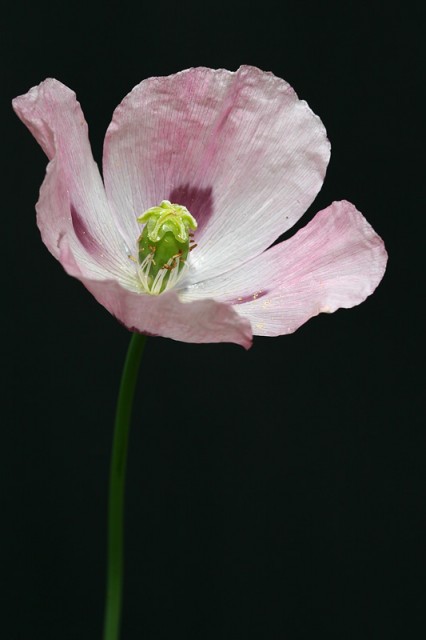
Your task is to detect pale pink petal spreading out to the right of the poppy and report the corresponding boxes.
[182,201,387,336]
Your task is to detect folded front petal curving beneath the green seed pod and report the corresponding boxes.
[60,239,253,349]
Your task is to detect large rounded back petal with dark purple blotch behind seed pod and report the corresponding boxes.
[104,66,330,282]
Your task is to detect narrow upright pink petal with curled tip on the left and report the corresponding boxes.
[13,78,128,277]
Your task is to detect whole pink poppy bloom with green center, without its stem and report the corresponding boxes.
[13,66,387,348]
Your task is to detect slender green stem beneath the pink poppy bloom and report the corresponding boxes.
[104,333,146,640]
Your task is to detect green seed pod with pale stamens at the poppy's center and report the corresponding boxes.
[137,200,197,295]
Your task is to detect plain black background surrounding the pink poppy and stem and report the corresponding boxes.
[1,0,426,640]
